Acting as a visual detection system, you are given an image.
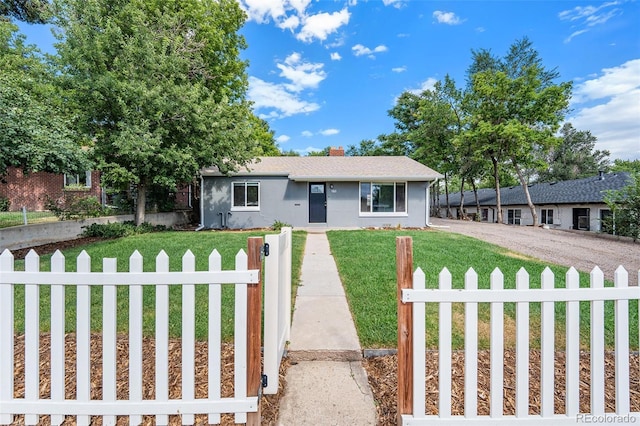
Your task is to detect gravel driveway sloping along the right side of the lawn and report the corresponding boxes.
[431,218,640,285]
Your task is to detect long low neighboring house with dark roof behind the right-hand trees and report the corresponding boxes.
[439,172,631,232]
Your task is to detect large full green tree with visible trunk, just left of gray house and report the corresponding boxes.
[57,0,262,224]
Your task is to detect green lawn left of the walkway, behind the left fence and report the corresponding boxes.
[10,231,306,340]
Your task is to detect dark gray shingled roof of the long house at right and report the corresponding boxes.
[440,172,631,207]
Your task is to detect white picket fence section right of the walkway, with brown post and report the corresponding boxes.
[396,237,640,426]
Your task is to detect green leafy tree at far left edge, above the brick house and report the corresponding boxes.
[0,20,89,175]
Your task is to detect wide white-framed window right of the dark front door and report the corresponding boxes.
[360,182,407,214]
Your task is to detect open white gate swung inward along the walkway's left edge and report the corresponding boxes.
[262,227,292,395]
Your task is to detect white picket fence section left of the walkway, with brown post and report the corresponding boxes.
[0,228,291,425]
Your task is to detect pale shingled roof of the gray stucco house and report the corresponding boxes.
[201,156,443,181]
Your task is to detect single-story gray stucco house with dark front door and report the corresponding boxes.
[200,154,441,229]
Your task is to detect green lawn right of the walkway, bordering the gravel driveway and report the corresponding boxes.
[327,230,638,349]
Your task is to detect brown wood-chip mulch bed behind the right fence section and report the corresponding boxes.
[364,351,640,425]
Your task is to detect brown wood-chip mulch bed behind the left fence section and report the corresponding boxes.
[8,333,289,426]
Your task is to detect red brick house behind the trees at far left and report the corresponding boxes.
[0,167,102,211]
